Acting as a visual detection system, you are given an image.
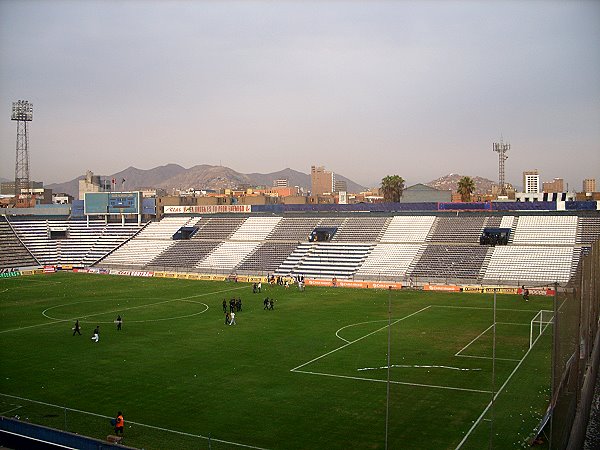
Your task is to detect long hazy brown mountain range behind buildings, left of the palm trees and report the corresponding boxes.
[47,164,364,197]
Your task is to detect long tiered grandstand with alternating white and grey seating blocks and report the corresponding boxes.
[0,211,600,285]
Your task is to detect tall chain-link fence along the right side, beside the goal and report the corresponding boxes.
[549,241,600,449]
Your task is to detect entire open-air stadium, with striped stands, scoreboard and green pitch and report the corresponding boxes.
[0,198,600,449]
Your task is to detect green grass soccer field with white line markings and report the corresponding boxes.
[0,273,552,449]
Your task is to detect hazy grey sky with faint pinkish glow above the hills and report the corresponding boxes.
[0,0,600,190]
